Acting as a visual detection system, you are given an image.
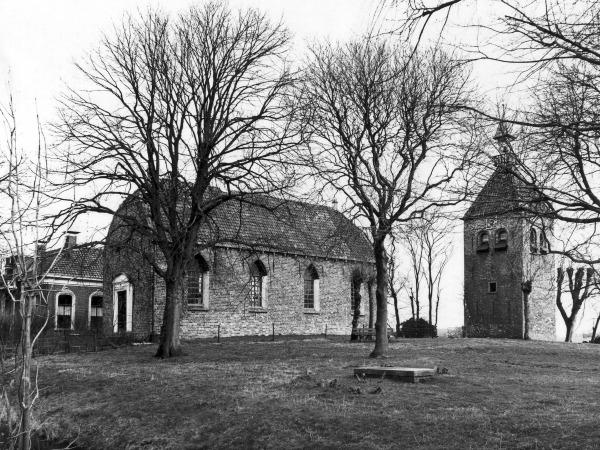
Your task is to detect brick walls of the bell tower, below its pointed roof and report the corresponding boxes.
[464,216,556,340]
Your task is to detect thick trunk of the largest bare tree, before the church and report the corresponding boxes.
[155,276,183,358]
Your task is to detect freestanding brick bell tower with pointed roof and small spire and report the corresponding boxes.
[463,123,556,340]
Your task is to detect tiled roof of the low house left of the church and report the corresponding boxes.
[39,245,102,280]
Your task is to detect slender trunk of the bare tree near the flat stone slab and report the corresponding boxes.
[369,235,388,358]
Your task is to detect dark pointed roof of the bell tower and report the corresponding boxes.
[463,164,543,220]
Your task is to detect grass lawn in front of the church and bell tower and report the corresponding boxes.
[25,339,600,450]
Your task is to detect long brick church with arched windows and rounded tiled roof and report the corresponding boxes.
[103,195,374,339]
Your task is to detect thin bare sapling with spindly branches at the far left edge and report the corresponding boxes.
[0,97,58,450]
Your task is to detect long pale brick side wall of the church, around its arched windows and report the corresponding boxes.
[155,248,368,338]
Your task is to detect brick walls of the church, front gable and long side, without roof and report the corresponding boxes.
[104,216,372,338]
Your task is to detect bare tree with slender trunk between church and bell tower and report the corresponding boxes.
[301,36,472,357]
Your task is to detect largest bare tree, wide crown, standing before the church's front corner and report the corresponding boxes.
[57,2,298,357]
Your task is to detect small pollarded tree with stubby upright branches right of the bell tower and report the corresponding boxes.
[556,267,594,342]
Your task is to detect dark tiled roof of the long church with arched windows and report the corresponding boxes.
[199,195,373,261]
